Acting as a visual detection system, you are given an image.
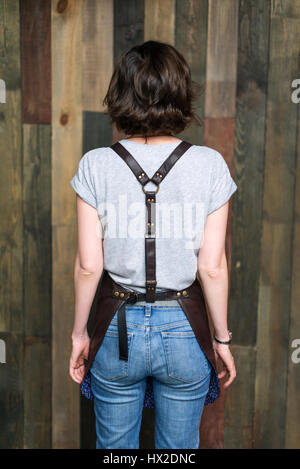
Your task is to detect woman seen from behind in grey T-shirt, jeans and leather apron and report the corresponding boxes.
[70,41,237,449]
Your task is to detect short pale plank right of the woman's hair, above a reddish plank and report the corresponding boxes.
[205,0,239,117]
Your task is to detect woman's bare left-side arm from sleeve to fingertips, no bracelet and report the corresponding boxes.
[69,195,103,383]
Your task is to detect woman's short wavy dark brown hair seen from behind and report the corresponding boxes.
[103,41,204,136]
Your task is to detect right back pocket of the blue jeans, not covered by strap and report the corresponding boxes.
[161,331,211,383]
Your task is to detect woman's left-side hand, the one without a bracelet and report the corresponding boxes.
[69,332,90,384]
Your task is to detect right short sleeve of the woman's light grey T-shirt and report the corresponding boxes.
[207,151,237,215]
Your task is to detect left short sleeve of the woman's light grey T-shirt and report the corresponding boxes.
[70,152,97,208]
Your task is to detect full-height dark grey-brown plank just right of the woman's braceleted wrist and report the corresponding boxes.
[224,0,269,448]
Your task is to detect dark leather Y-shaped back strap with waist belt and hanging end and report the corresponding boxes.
[111,140,192,361]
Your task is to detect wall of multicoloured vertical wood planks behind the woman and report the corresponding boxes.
[0,0,300,448]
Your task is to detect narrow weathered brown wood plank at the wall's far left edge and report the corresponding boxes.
[0,0,24,449]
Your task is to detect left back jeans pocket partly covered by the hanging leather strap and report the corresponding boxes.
[91,330,133,381]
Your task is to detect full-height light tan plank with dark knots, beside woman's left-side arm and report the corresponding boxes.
[52,0,82,449]
